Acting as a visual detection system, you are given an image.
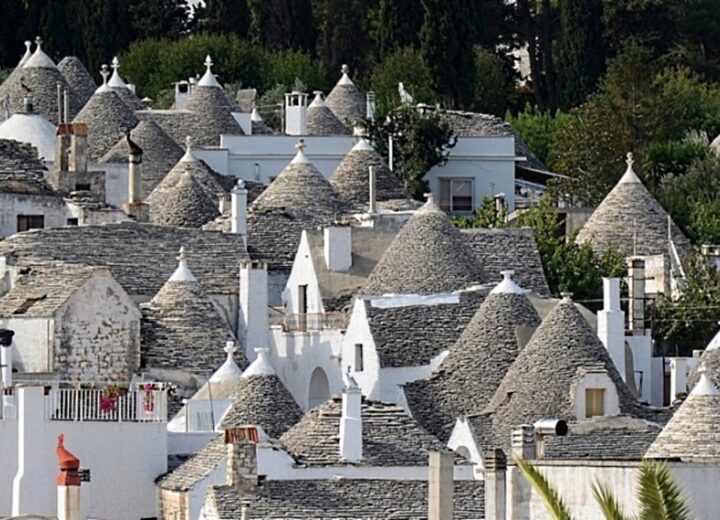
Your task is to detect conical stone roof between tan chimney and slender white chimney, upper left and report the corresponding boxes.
[146,145,225,227]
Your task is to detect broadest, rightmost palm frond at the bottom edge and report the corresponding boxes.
[638,460,691,520]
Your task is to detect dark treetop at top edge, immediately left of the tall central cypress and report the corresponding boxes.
[371,0,423,60]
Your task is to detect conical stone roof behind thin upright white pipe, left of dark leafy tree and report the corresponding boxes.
[330,139,412,210]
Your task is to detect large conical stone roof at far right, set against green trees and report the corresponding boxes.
[575,154,690,256]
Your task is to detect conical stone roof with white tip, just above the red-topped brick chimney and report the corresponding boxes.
[222,349,303,438]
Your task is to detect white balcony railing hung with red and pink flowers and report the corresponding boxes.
[45,383,167,422]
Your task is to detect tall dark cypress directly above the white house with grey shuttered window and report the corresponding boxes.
[420,0,475,108]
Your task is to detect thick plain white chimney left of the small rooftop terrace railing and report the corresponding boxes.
[238,261,270,361]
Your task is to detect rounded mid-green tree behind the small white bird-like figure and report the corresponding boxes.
[370,47,439,118]
